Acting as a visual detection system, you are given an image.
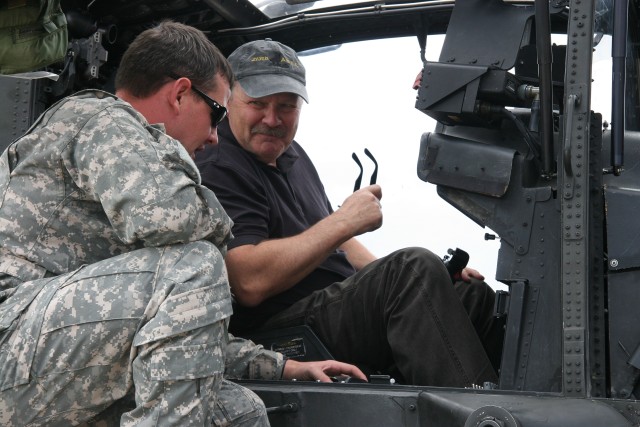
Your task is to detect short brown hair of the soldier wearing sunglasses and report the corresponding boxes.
[115,21,234,98]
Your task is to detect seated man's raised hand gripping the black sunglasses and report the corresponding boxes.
[334,185,382,236]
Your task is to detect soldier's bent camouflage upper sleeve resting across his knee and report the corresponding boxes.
[63,106,232,248]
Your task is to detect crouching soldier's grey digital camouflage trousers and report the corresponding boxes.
[0,242,268,426]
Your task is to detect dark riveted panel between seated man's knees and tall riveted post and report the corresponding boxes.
[438,155,562,392]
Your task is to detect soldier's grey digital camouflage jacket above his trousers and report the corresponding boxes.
[0,91,231,286]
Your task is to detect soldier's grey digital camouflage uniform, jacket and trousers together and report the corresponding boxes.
[0,91,284,426]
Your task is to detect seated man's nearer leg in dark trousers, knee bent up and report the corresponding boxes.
[258,248,497,387]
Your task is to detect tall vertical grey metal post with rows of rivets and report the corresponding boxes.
[558,0,595,396]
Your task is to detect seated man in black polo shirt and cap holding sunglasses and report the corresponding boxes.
[196,40,497,386]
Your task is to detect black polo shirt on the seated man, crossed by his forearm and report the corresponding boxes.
[196,121,355,333]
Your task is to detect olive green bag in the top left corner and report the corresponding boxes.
[0,0,68,74]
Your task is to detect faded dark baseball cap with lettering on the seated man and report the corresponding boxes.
[228,39,309,102]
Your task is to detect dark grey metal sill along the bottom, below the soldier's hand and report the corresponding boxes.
[240,381,640,427]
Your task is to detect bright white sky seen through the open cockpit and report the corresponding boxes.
[296,37,611,289]
